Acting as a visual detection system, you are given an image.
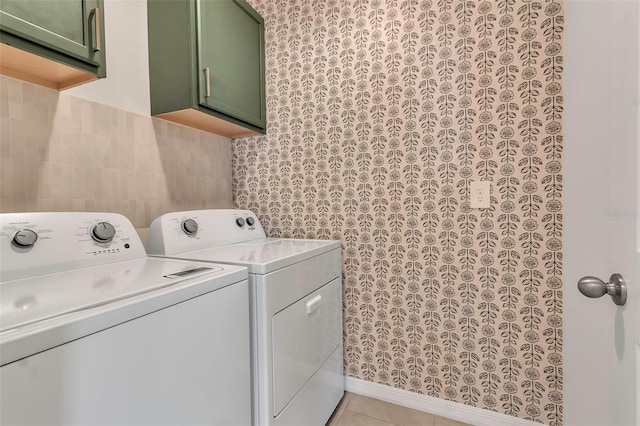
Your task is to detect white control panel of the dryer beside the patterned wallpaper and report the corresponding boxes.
[147,209,266,255]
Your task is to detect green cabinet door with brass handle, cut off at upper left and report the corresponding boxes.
[0,0,104,66]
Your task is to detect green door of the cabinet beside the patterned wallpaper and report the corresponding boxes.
[197,0,266,128]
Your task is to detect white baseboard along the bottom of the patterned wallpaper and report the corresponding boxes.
[344,377,540,426]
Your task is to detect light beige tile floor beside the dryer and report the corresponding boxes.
[327,392,467,426]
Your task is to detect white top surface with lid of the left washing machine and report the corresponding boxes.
[0,258,246,333]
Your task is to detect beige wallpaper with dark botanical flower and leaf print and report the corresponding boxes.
[233,0,564,425]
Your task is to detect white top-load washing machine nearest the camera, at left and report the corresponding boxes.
[0,213,251,426]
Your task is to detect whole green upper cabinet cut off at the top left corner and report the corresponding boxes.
[0,0,106,89]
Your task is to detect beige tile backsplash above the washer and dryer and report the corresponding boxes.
[0,76,232,228]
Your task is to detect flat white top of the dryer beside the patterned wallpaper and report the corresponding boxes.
[158,238,340,275]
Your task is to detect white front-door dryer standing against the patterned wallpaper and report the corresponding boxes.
[147,210,344,426]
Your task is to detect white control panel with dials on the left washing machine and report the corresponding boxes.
[0,213,146,281]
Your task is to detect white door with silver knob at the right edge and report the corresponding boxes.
[563,0,640,426]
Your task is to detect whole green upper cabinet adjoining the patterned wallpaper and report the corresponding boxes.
[148,0,266,137]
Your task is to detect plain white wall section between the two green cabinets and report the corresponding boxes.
[65,0,151,115]
